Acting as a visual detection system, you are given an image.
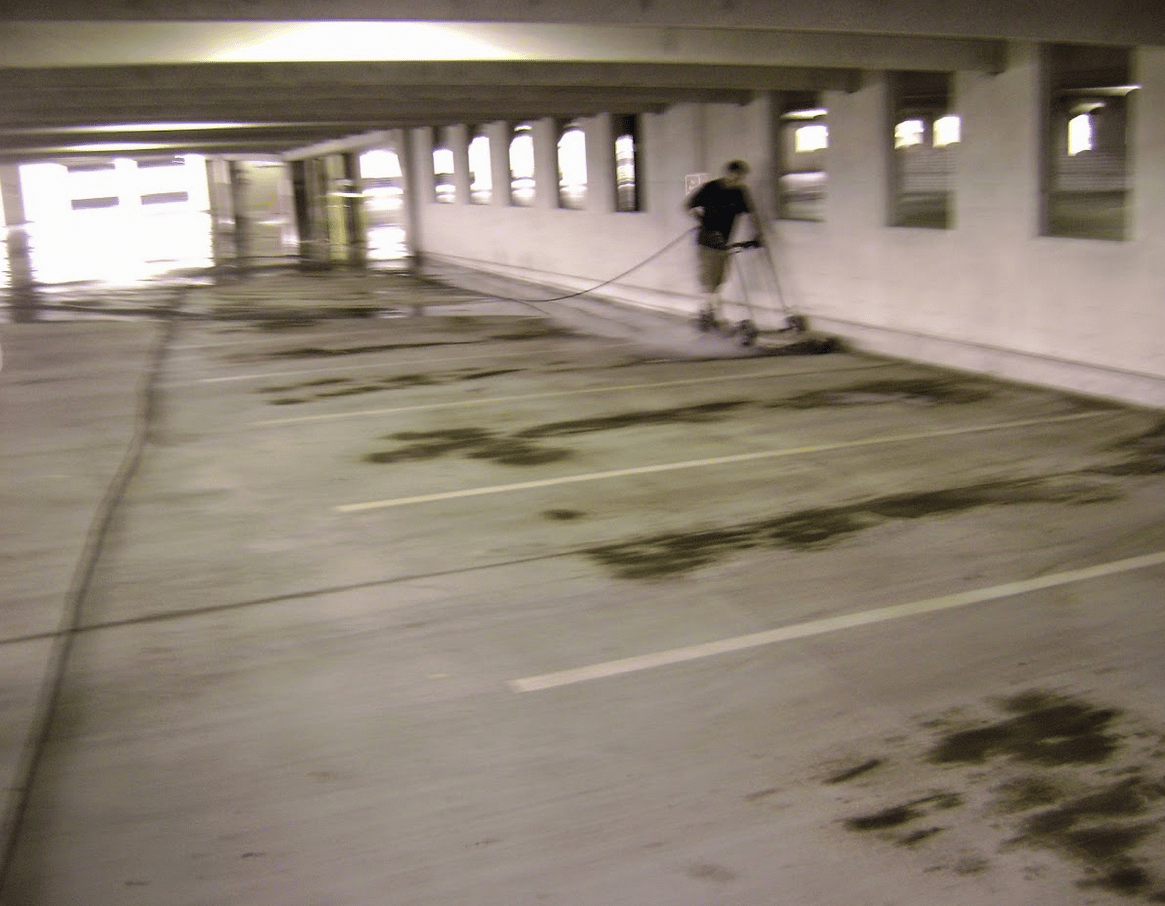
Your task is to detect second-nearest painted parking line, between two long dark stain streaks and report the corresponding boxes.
[334,410,1113,512]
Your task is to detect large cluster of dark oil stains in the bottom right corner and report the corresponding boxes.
[822,691,1165,903]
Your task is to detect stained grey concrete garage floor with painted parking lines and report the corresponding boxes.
[0,267,1165,906]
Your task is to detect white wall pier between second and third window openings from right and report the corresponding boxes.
[825,72,894,233]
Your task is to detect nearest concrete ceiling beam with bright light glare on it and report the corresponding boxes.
[0,21,1003,71]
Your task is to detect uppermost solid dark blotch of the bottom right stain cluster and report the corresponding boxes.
[930,696,1120,767]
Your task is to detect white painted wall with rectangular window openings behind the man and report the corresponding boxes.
[414,43,1165,405]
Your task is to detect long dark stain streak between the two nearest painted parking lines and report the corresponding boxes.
[585,479,1118,579]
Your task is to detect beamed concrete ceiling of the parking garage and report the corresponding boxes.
[0,0,1155,162]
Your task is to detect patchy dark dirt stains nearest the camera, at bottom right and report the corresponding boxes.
[831,691,1165,903]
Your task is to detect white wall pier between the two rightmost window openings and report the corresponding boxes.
[955,43,1051,242]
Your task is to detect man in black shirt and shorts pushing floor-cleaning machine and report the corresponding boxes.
[686,161,761,328]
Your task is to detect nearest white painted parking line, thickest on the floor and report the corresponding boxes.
[506,551,1165,692]
